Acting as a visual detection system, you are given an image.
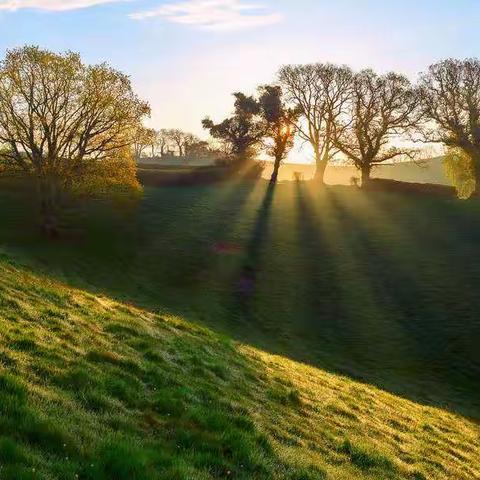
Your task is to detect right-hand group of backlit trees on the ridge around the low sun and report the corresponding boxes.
[203,59,480,196]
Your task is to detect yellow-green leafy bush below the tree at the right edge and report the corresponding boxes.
[444,148,477,199]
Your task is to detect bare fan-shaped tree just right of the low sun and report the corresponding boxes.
[279,64,352,183]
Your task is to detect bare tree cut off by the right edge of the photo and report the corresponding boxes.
[420,58,480,194]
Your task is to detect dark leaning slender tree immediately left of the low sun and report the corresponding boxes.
[259,85,300,183]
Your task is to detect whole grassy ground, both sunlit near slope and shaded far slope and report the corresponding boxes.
[0,181,480,480]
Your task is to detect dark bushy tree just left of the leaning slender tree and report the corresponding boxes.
[202,93,264,164]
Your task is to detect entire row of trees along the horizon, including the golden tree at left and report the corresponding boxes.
[0,47,480,235]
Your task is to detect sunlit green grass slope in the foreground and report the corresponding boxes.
[0,255,480,480]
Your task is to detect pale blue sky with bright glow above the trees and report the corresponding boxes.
[0,0,480,161]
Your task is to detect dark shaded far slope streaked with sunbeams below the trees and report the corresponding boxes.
[0,177,480,421]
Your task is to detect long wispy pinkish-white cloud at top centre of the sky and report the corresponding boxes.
[130,0,282,31]
